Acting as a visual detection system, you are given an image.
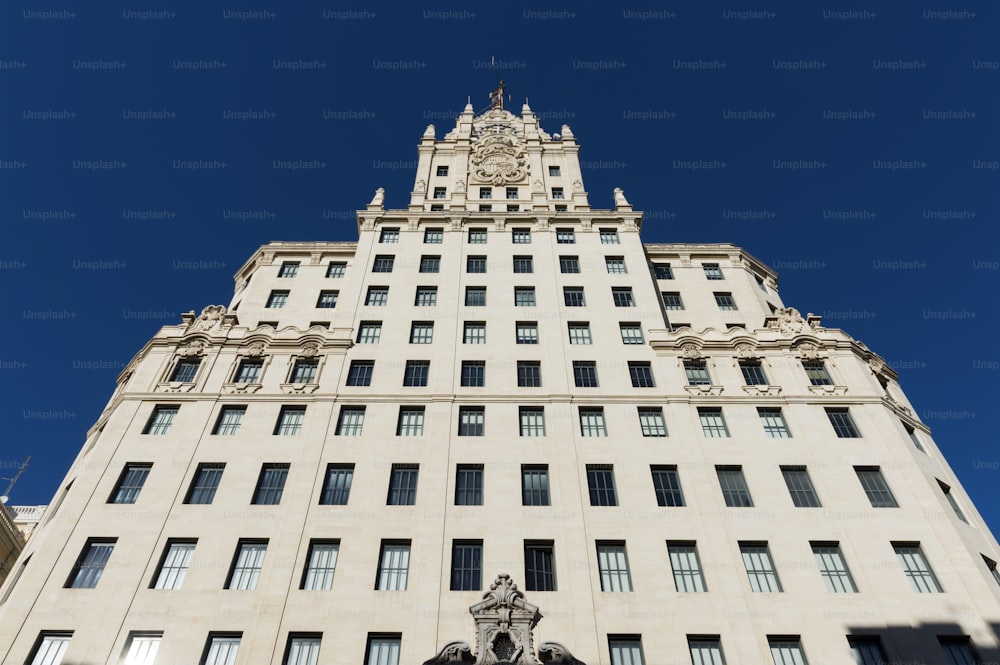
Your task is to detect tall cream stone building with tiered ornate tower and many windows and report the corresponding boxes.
[0,98,1000,665]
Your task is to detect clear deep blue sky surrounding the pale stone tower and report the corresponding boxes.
[0,0,1000,533]
